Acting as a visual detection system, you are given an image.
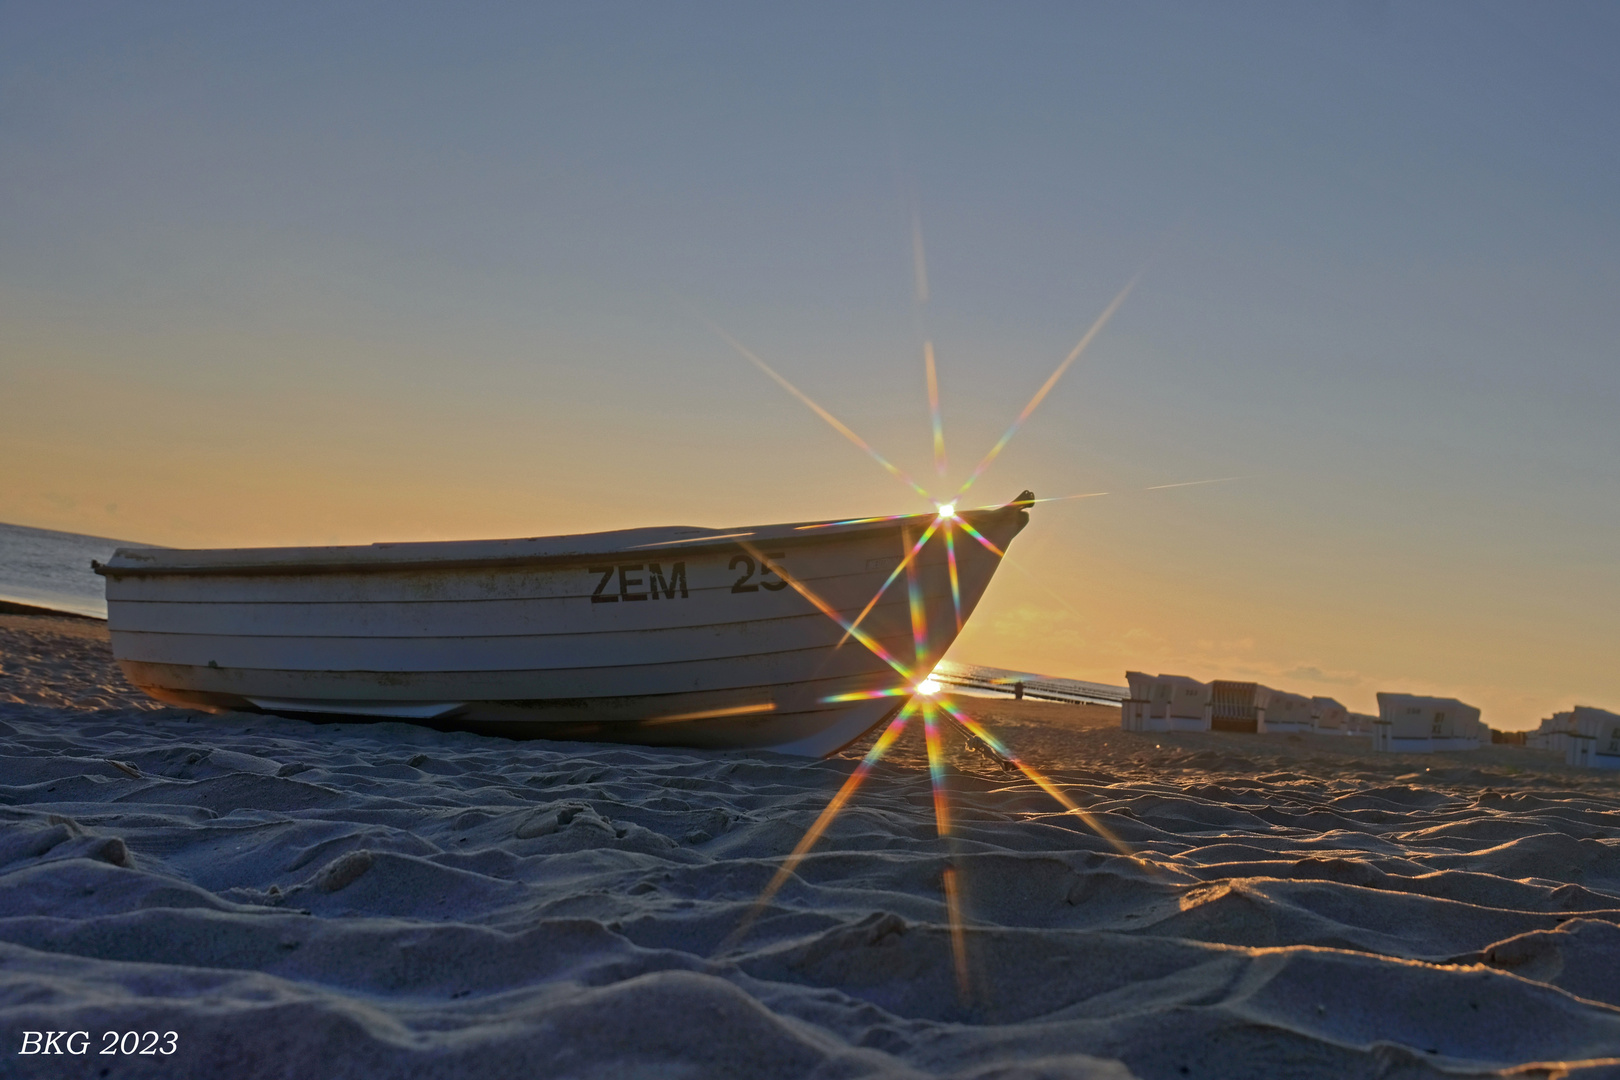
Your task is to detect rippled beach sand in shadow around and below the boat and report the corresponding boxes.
[0,615,1620,1080]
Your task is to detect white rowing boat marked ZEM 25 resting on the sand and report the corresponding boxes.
[96,492,1034,756]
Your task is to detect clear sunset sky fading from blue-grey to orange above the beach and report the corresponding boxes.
[0,2,1620,729]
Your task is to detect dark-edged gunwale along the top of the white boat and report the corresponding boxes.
[91,499,1027,578]
